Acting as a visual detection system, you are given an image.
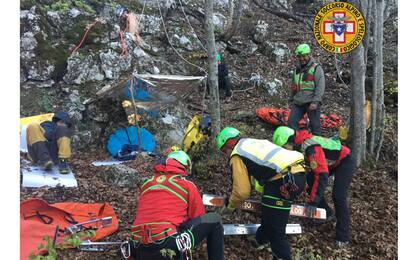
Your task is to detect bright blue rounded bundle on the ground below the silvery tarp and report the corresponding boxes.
[107,126,156,158]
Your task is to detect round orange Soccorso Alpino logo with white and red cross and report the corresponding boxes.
[313,2,365,54]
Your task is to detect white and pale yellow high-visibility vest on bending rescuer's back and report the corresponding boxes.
[231,138,304,173]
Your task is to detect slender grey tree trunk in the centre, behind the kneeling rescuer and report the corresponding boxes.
[205,0,221,147]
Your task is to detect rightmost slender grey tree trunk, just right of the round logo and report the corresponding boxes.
[369,0,384,154]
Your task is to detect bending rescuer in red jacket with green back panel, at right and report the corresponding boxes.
[273,126,355,247]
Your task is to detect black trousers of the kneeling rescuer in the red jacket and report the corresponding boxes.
[132,222,224,260]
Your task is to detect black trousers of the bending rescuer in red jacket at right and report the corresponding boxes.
[307,155,355,242]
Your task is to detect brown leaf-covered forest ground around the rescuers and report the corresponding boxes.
[20,1,398,260]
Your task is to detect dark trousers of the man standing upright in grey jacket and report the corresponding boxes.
[287,103,322,135]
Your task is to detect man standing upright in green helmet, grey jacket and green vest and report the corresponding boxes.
[288,43,325,135]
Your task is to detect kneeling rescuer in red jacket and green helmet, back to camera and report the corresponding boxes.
[132,151,224,260]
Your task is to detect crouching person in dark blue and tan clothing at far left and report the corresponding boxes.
[26,111,71,174]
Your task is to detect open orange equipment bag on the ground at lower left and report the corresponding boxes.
[20,199,118,260]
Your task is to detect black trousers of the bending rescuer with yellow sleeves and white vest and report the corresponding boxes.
[256,173,306,260]
